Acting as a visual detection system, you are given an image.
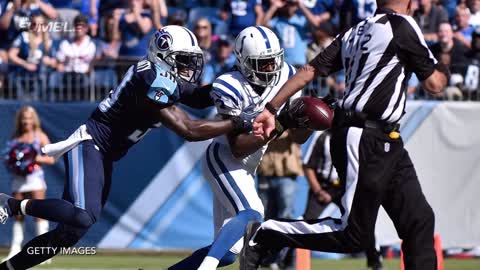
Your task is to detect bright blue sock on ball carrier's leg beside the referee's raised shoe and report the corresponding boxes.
[207,209,262,260]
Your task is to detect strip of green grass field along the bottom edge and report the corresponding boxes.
[2,253,480,270]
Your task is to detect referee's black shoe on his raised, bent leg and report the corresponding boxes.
[240,221,265,270]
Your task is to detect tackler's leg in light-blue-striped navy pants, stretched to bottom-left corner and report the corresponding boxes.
[0,141,111,270]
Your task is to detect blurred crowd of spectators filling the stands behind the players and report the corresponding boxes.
[0,0,480,101]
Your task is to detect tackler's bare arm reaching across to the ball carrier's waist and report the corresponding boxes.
[158,106,248,141]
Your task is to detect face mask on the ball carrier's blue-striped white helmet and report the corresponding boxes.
[244,50,283,86]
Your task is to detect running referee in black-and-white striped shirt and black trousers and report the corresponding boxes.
[240,0,449,270]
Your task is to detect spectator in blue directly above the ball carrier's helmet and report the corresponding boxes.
[220,0,263,38]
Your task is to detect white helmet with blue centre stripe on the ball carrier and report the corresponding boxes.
[234,26,283,87]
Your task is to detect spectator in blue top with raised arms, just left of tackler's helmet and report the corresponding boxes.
[113,0,153,61]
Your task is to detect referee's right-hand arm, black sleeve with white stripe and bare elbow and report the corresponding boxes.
[390,16,450,95]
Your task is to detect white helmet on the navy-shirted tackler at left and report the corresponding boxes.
[147,25,203,83]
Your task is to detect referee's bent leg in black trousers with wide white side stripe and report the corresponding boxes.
[240,128,403,269]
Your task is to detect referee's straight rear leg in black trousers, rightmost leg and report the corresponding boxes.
[382,150,437,270]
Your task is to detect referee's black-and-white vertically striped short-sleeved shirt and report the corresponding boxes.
[310,8,437,123]
